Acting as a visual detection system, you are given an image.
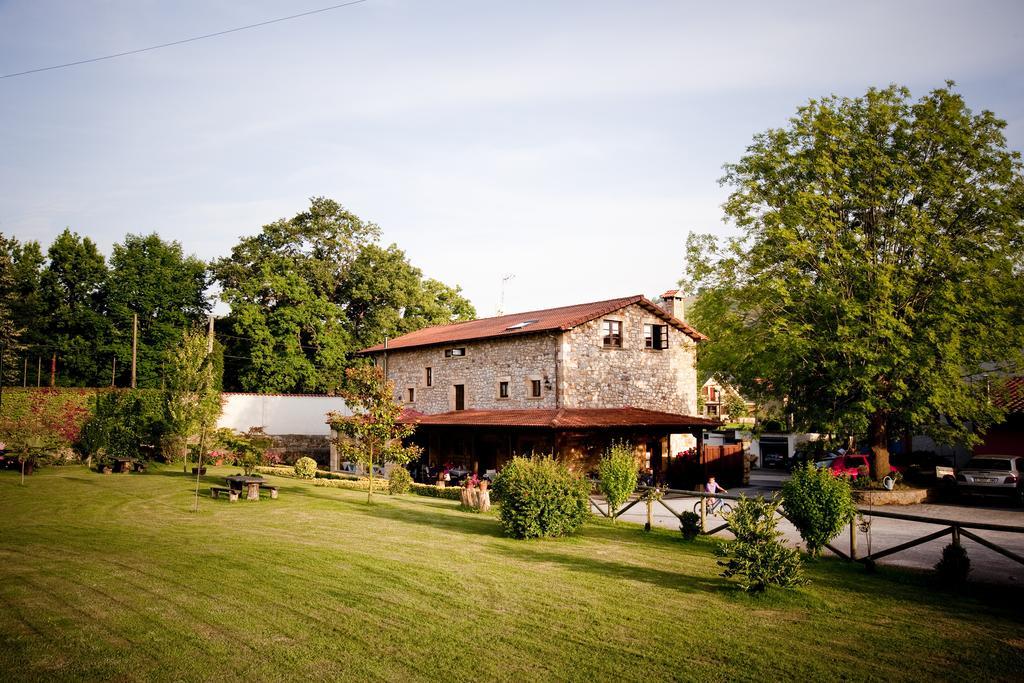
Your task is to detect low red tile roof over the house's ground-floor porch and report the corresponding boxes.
[402,408,721,429]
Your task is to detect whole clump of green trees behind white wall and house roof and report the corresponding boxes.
[213,198,474,392]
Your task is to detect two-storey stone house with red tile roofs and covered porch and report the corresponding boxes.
[360,293,718,481]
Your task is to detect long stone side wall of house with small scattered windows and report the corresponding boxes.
[375,333,558,414]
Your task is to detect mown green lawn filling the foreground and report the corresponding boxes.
[0,467,1024,681]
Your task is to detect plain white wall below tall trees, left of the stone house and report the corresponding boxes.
[217,393,352,436]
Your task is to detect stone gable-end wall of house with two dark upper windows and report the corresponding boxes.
[560,305,697,415]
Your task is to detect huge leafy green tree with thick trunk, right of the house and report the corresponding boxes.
[683,84,1024,476]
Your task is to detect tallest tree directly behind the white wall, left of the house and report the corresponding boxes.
[213,198,379,392]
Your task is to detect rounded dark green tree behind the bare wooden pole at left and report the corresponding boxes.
[103,233,210,388]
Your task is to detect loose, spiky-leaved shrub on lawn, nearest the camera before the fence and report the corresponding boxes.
[716,497,805,593]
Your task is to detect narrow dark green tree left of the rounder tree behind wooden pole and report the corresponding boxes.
[39,229,110,386]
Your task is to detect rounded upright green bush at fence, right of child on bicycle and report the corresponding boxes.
[782,462,857,556]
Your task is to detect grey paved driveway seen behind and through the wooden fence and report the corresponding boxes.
[595,470,1024,586]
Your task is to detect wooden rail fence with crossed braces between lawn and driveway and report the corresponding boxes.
[590,486,1024,564]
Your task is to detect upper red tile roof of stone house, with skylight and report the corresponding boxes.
[359,295,707,353]
